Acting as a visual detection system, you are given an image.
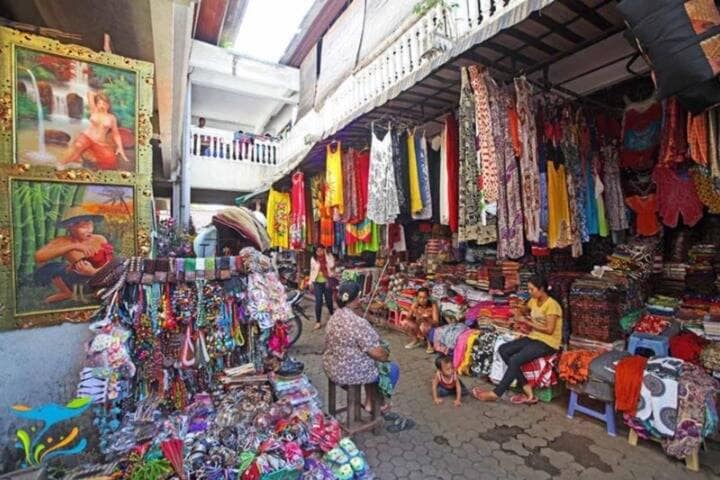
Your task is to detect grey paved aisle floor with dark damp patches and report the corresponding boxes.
[291,304,720,480]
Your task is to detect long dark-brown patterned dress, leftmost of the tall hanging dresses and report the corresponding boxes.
[462,68,497,244]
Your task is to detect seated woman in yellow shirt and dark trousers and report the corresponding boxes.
[472,275,562,404]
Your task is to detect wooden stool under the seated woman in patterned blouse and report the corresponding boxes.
[328,378,383,436]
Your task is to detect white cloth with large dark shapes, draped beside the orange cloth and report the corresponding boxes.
[635,357,684,437]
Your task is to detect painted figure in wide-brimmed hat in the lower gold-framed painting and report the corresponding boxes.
[34,207,113,303]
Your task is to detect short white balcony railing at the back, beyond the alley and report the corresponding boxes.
[190,126,279,165]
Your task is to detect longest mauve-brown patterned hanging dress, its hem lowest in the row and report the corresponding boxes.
[485,76,525,259]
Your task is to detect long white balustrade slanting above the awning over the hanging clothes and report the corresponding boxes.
[278,0,552,178]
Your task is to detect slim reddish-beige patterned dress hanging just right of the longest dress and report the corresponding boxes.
[515,77,541,242]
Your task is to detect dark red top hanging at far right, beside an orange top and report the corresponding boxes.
[652,166,703,228]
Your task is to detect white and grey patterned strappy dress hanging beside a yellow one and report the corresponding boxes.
[367,123,400,225]
